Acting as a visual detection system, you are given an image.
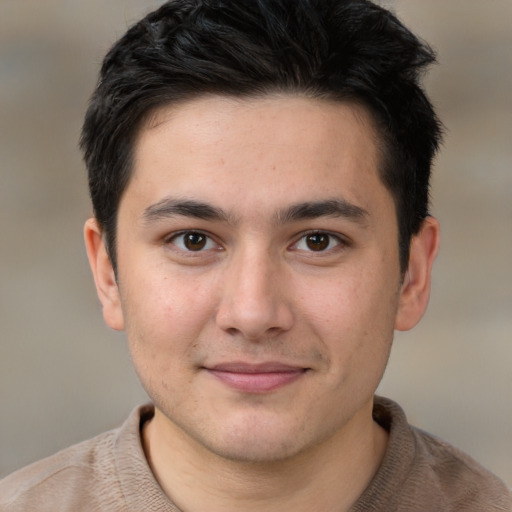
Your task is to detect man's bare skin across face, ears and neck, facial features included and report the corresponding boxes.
[85,96,439,511]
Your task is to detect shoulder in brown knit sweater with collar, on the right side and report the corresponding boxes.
[362,397,512,512]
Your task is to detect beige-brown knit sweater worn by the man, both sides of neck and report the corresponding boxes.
[0,398,512,512]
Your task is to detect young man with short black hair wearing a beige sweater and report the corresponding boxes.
[0,0,511,512]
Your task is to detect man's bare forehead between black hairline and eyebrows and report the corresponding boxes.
[127,95,388,218]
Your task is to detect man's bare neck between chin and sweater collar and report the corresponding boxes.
[143,404,387,512]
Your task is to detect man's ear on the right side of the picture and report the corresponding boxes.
[395,217,440,331]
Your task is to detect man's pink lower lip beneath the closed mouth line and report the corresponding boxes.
[208,370,306,393]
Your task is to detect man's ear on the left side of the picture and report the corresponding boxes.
[84,218,124,331]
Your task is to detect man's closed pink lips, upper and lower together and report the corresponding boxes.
[205,362,308,393]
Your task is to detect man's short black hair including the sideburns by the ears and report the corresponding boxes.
[80,0,442,272]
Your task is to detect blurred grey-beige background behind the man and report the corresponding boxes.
[0,0,512,486]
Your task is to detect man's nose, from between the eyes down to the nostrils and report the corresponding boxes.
[217,250,294,341]
